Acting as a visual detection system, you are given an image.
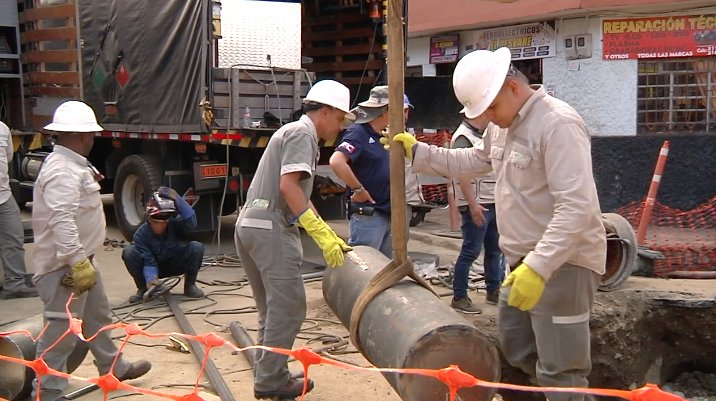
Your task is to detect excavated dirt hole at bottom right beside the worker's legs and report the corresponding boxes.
[496,288,716,401]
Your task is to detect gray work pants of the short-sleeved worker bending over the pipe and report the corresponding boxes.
[234,211,306,391]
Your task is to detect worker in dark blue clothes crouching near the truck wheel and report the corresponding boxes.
[122,187,204,303]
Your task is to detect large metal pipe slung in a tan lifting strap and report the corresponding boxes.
[323,246,500,401]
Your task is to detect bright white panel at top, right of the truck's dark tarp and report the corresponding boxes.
[219,0,301,69]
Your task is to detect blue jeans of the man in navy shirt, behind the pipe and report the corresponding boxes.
[348,210,393,258]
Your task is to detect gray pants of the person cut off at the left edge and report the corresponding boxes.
[0,196,27,292]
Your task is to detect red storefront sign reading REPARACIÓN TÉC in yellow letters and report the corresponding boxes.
[602,14,716,60]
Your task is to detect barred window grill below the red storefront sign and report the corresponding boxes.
[637,58,716,134]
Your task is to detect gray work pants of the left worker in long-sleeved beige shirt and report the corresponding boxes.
[32,261,130,401]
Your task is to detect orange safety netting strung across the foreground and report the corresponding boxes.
[0,297,685,401]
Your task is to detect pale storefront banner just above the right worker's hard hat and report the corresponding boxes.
[474,22,556,60]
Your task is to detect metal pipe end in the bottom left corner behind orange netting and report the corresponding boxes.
[0,315,89,400]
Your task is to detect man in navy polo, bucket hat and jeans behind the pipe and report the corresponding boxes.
[330,86,393,258]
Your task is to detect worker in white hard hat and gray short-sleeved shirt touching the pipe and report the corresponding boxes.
[234,80,355,399]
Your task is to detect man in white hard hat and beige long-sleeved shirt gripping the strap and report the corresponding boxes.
[386,48,606,401]
